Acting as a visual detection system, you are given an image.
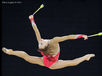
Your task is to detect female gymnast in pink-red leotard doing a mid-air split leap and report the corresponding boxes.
[2,15,95,69]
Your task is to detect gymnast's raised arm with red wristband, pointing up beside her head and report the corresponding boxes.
[29,15,41,42]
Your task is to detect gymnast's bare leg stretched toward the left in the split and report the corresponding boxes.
[2,48,44,66]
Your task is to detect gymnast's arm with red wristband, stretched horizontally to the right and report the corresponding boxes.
[52,34,88,43]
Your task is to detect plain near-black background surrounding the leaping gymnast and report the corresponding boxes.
[1,0,102,76]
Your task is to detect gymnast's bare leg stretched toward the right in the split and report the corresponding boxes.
[50,54,95,69]
